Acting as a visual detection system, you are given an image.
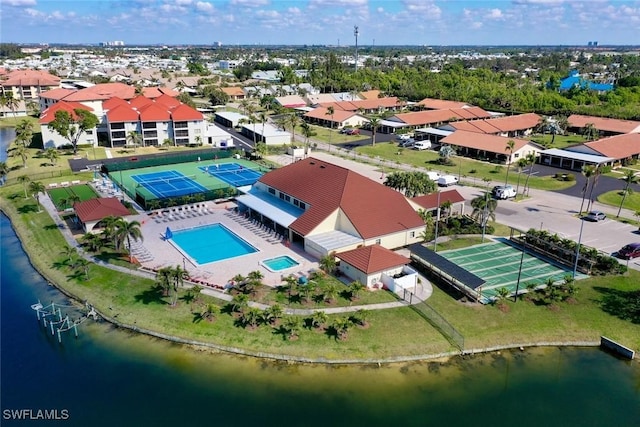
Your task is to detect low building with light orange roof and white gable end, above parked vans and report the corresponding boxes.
[440,130,544,163]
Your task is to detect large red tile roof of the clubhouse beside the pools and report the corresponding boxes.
[260,157,424,239]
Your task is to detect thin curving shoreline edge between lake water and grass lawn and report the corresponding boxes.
[0,206,612,365]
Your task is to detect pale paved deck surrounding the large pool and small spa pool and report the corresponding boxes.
[138,202,318,287]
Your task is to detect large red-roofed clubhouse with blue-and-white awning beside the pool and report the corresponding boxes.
[237,157,424,258]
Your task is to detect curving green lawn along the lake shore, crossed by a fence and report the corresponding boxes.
[0,185,640,359]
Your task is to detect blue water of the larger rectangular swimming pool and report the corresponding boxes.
[172,224,258,264]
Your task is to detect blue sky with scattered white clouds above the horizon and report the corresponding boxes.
[0,0,640,46]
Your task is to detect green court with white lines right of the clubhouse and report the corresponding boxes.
[438,241,587,300]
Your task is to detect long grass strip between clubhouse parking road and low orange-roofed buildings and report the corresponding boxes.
[355,142,575,191]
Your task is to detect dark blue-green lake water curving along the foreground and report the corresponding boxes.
[0,215,640,427]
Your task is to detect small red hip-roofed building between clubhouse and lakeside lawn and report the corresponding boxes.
[336,245,418,292]
